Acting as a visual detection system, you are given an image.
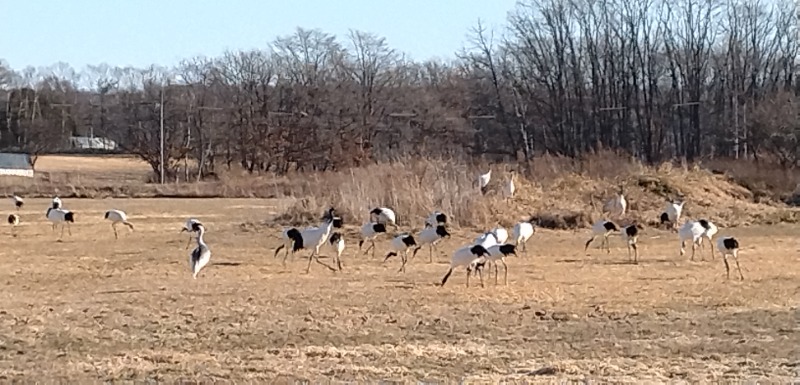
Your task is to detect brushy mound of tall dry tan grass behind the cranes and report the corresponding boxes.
[270,153,800,229]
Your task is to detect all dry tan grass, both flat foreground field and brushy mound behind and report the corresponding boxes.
[0,155,800,383]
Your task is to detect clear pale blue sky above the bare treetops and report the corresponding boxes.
[0,0,516,69]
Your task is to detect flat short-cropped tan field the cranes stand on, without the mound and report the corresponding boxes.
[0,199,800,383]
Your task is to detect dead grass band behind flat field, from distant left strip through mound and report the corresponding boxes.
[6,152,800,229]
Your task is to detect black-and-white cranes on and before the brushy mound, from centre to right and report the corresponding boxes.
[260,170,744,285]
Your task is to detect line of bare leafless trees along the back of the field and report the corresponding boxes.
[0,0,800,180]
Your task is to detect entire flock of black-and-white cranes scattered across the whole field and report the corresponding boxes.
[8,171,744,286]
